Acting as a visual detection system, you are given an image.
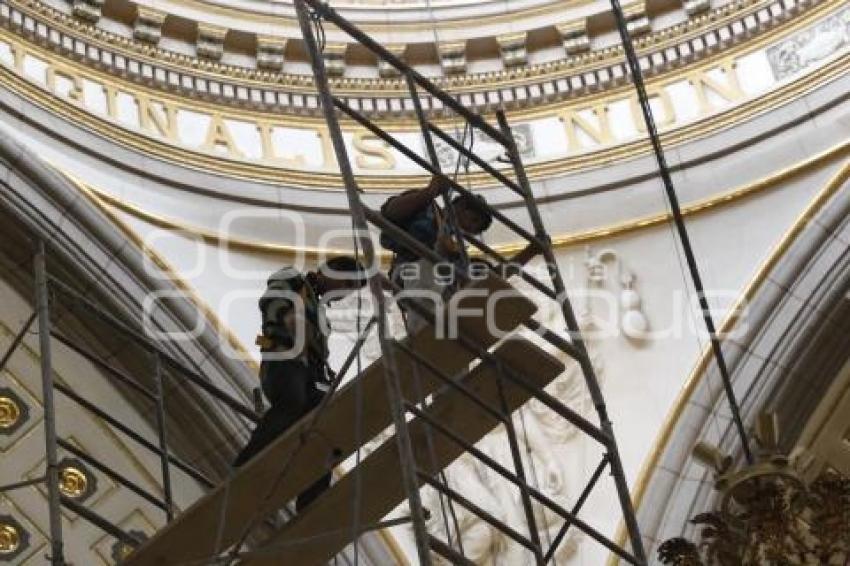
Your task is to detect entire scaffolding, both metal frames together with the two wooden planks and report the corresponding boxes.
[4,0,646,565]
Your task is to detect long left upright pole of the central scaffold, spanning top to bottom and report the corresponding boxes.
[295,0,438,566]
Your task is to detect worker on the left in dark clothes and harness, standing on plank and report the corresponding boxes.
[233,256,367,510]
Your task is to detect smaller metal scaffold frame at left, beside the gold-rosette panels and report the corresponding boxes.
[0,240,259,565]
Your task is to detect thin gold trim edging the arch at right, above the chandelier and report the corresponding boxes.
[608,154,850,566]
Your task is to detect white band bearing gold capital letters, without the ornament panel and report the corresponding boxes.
[4,26,767,174]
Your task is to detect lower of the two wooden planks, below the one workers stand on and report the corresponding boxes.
[240,339,564,566]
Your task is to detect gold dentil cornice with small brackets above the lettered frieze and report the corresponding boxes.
[0,0,818,118]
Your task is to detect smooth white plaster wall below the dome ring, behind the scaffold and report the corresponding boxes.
[91,149,835,566]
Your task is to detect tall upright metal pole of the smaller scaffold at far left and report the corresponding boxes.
[35,241,65,566]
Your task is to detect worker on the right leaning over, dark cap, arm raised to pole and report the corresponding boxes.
[380,175,493,333]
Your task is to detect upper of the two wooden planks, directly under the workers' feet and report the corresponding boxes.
[125,276,537,566]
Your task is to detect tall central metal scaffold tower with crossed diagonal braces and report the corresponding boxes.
[278,0,646,564]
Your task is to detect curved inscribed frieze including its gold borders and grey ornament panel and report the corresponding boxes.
[0,0,850,190]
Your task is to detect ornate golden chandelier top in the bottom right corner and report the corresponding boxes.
[658,415,850,566]
